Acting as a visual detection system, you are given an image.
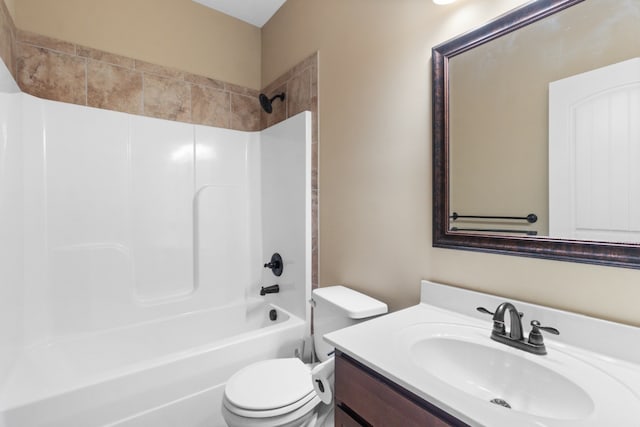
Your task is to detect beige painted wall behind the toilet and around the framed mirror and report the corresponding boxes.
[262,0,640,325]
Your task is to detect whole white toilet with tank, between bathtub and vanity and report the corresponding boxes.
[222,286,387,427]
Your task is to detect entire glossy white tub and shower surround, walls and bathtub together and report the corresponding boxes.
[0,52,311,426]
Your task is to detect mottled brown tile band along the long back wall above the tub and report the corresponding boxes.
[15,29,260,131]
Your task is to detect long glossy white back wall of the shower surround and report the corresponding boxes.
[22,95,260,342]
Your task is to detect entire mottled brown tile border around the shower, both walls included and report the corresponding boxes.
[0,19,319,288]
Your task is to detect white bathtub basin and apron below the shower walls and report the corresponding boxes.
[0,300,306,427]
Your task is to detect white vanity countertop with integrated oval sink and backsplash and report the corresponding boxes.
[325,281,640,427]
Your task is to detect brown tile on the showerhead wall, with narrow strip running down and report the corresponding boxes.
[261,52,319,288]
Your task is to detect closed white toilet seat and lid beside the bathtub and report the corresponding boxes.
[223,358,320,418]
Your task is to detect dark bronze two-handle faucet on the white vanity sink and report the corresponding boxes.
[477,302,560,355]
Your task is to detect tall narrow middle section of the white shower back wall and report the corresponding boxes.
[131,116,194,303]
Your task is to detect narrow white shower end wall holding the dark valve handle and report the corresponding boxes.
[260,111,312,319]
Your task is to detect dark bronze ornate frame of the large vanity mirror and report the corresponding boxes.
[432,0,640,268]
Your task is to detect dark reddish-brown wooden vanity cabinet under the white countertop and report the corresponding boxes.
[335,351,467,427]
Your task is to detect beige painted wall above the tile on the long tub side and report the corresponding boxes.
[13,0,260,89]
